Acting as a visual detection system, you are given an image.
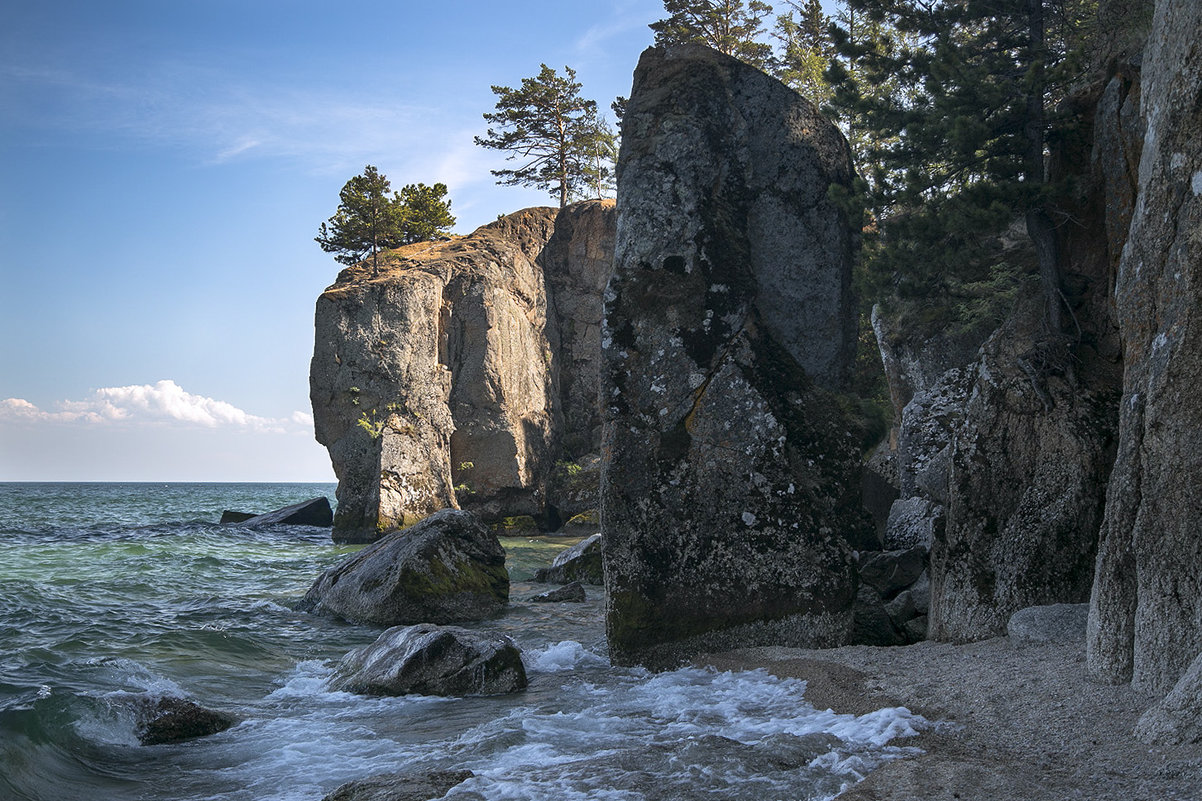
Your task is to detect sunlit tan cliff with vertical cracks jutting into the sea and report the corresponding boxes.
[310,201,613,541]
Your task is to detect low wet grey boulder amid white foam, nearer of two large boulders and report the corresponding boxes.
[331,624,526,695]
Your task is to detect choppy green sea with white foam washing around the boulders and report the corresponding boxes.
[0,483,923,801]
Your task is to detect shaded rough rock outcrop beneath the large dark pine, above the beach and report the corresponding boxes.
[929,286,1115,641]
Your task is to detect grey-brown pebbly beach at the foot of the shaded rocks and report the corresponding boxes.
[694,637,1202,801]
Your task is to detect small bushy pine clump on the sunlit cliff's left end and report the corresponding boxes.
[314,165,454,274]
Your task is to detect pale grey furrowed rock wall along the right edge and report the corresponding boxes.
[1087,0,1202,693]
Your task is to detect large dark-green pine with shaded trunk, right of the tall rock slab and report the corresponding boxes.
[827,0,1096,329]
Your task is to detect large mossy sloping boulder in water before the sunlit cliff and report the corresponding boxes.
[299,510,510,625]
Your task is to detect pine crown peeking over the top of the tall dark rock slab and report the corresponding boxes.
[649,0,772,70]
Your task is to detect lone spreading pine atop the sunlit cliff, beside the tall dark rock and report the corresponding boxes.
[476,64,615,208]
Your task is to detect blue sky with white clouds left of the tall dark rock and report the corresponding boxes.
[0,0,662,481]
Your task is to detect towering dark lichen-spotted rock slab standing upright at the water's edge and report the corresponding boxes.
[601,47,865,666]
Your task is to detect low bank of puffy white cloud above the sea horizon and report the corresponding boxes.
[0,379,313,433]
